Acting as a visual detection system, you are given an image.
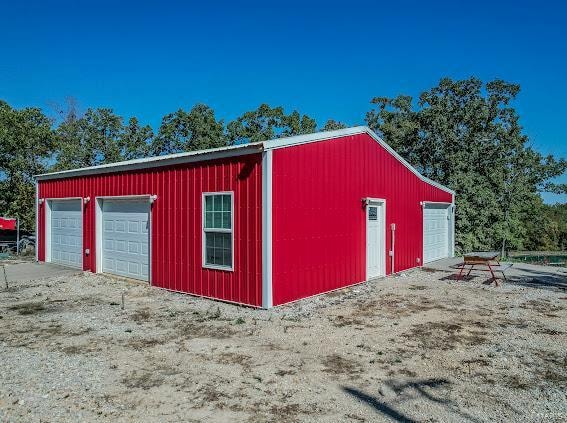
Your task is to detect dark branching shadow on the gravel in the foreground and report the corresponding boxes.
[342,379,479,422]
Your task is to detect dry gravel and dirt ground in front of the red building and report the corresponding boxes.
[0,264,567,422]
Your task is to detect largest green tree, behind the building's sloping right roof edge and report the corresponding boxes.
[366,78,567,250]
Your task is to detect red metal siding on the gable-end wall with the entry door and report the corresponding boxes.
[272,134,452,305]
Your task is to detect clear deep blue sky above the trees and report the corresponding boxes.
[0,0,567,201]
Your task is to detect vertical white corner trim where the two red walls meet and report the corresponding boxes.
[262,150,273,309]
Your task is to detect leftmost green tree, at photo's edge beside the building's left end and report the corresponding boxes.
[0,100,54,231]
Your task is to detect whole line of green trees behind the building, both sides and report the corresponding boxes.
[0,78,567,255]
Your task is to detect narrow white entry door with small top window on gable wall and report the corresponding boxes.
[366,202,386,279]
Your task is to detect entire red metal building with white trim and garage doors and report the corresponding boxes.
[36,127,454,308]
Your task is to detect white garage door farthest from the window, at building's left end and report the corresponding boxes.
[51,200,83,268]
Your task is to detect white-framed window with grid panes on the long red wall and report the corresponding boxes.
[203,193,233,269]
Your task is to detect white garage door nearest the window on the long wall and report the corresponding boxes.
[102,200,150,281]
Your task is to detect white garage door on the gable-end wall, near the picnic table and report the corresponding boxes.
[423,204,450,263]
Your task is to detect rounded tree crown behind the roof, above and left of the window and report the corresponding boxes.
[151,104,227,156]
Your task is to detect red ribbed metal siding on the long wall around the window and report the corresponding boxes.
[38,154,262,306]
